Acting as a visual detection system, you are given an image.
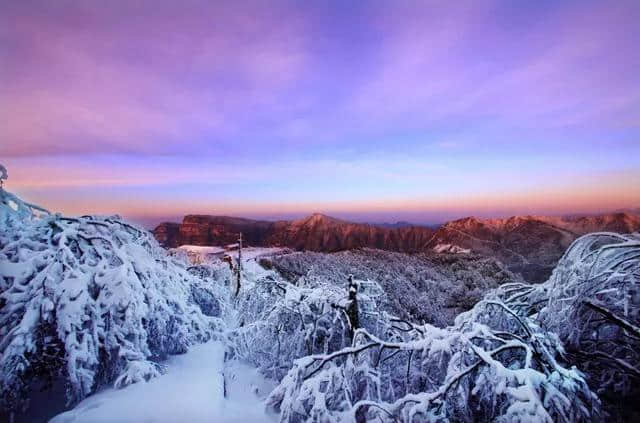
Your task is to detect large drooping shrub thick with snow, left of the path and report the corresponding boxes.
[0,188,225,409]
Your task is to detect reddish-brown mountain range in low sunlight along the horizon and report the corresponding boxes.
[153,212,640,282]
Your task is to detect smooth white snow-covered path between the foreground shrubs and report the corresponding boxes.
[50,342,276,423]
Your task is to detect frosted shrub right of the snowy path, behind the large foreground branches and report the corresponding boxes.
[229,272,396,380]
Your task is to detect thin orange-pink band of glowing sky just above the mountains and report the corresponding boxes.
[12,168,640,224]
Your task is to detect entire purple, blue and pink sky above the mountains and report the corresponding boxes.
[0,0,640,229]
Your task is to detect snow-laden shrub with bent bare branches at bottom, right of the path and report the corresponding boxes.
[268,302,599,423]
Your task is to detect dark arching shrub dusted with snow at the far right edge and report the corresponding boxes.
[494,233,640,420]
